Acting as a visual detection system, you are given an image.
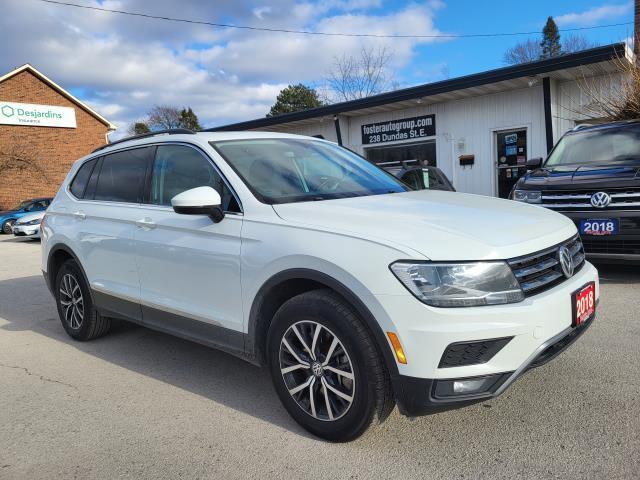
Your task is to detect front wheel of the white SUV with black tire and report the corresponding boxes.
[267,290,394,442]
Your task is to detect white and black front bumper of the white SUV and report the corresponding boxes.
[375,262,600,415]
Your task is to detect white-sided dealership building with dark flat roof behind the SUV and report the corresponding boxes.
[211,43,633,197]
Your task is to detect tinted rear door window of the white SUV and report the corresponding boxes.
[94,148,149,203]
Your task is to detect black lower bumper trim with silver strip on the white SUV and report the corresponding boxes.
[394,314,596,417]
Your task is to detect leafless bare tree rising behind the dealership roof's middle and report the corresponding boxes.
[325,47,394,101]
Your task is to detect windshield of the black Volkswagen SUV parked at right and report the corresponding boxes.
[545,126,640,167]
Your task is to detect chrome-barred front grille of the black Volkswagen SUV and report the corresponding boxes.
[541,188,640,210]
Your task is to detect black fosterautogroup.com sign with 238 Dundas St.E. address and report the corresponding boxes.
[362,115,436,145]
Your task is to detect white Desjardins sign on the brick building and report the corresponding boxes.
[0,100,76,128]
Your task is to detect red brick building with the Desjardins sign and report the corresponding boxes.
[0,64,116,210]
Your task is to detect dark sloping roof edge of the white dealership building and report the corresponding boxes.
[206,43,631,131]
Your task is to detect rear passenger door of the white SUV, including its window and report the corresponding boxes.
[69,147,153,320]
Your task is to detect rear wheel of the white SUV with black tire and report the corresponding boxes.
[54,260,111,341]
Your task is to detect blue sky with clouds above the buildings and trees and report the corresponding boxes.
[0,0,633,139]
